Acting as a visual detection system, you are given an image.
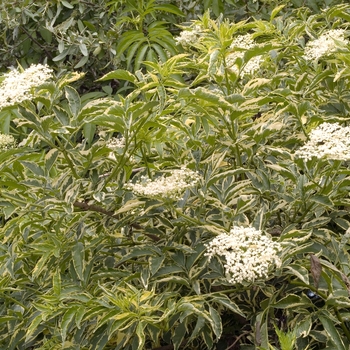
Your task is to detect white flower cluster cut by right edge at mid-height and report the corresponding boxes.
[295,123,350,160]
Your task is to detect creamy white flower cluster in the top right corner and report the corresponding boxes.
[303,29,349,61]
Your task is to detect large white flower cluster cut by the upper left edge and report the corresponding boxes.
[0,64,53,109]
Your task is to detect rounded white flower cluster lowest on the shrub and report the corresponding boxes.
[205,226,282,284]
